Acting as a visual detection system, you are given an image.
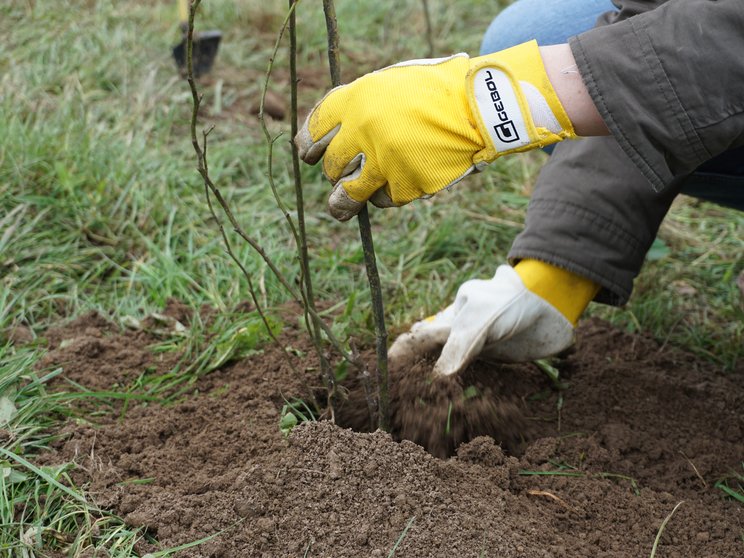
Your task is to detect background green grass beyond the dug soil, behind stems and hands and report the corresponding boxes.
[0,1,744,354]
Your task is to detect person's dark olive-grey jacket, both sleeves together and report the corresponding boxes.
[508,0,744,305]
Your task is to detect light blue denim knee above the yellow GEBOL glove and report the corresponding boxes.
[480,0,617,54]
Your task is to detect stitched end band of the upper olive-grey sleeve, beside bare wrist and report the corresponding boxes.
[569,14,711,191]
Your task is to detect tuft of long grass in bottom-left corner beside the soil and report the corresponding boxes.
[0,345,142,556]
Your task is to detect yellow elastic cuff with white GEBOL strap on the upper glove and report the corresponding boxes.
[466,41,576,165]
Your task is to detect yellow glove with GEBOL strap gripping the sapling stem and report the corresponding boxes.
[295,41,576,221]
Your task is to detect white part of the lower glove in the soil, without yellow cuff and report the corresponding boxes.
[388,265,574,376]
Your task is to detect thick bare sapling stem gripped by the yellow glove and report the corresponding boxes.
[323,0,390,431]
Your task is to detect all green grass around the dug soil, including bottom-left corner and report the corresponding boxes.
[0,0,744,556]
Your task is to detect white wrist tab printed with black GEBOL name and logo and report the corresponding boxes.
[473,68,530,152]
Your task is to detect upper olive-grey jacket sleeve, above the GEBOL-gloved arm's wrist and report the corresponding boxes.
[570,0,744,191]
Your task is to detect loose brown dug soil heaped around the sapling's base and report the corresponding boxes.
[32,307,744,558]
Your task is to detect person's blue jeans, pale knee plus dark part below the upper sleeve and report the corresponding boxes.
[481,0,744,211]
